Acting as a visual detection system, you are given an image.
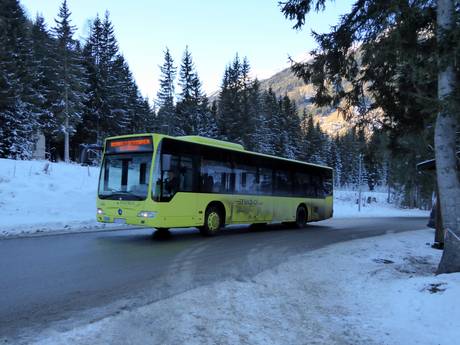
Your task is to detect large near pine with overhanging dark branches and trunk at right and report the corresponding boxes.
[282,0,460,273]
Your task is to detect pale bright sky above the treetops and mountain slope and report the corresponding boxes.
[20,0,352,100]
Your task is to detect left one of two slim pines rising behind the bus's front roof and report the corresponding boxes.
[157,47,176,135]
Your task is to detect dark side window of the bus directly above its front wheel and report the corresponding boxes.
[201,159,235,193]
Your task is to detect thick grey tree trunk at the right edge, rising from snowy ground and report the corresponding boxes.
[434,0,460,274]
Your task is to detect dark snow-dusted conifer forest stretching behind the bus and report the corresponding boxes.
[0,0,433,207]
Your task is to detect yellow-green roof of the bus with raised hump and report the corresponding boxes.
[105,133,332,170]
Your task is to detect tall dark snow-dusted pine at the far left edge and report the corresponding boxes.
[0,0,39,158]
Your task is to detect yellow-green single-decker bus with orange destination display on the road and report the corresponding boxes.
[97,134,333,236]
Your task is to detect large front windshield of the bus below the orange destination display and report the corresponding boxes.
[99,153,152,200]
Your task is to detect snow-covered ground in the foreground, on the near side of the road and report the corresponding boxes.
[31,230,460,345]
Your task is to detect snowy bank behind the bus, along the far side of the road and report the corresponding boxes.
[0,159,428,236]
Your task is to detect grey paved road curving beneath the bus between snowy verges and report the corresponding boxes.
[0,218,426,343]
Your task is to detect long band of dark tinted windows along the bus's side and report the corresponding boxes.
[155,138,332,201]
